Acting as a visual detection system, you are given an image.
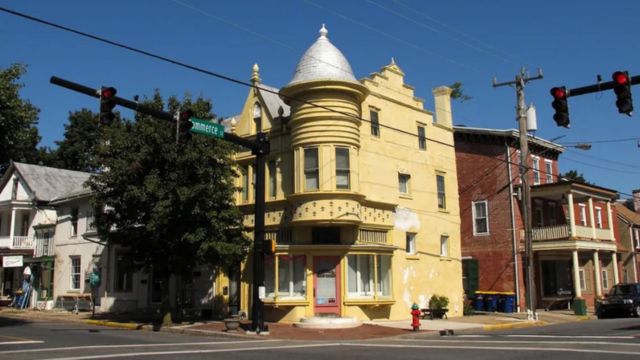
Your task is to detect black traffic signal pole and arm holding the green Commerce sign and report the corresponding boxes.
[49,76,271,334]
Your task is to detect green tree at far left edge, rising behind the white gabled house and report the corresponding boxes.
[0,64,41,175]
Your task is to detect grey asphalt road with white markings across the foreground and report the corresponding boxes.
[0,318,640,360]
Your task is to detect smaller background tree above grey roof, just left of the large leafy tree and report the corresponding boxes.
[50,109,104,172]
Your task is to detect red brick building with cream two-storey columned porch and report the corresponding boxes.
[454,127,618,308]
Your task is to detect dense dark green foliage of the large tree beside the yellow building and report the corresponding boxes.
[89,92,249,278]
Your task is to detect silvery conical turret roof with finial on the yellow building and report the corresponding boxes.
[287,24,358,86]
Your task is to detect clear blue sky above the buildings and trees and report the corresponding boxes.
[0,0,640,197]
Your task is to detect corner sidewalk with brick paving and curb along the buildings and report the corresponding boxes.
[0,308,595,340]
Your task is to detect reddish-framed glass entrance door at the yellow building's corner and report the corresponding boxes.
[313,256,340,316]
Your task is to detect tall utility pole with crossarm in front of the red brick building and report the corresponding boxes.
[493,68,543,320]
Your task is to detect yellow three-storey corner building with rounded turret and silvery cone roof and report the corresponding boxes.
[217,26,463,322]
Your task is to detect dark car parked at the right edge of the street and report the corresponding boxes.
[596,283,640,319]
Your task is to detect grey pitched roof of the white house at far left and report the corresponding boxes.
[2,162,91,201]
